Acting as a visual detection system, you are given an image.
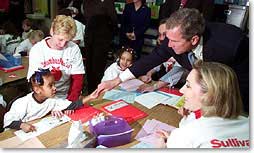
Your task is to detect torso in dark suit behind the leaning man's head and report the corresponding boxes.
[159,0,214,21]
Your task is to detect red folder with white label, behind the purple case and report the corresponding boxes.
[102,100,147,123]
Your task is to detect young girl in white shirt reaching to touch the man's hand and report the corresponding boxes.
[4,69,98,132]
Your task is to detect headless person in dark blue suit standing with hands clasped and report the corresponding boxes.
[120,0,151,58]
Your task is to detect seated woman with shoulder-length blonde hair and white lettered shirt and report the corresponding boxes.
[158,61,250,148]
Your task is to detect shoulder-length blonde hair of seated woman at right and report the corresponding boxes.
[193,60,242,118]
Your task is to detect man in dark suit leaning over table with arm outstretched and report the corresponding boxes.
[98,8,249,112]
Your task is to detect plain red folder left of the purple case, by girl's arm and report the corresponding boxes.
[68,105,101,123]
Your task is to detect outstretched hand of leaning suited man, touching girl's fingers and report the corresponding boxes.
[96,77,121,94]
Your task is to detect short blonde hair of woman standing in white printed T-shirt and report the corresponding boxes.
[51,15,77,40]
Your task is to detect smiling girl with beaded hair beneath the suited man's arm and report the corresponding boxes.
[101,47,135,82]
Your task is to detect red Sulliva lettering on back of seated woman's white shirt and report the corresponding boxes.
[210,138,250,148]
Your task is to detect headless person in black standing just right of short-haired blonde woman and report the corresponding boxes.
[83,0,117,93]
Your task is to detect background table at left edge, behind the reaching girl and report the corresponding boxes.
[0,56,29,103]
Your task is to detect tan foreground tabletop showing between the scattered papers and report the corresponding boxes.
[0,91,181,148]
